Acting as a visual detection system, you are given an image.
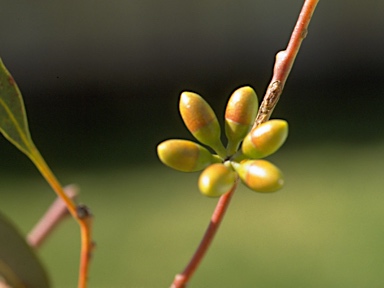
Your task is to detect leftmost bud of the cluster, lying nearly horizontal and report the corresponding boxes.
[157,139,221,172]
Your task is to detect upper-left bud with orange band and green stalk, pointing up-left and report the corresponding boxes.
[179,92,226,158]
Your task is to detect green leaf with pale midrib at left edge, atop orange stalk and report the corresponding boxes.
[0,59,35,157]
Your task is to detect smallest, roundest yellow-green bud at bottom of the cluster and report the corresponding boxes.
[198,163,236,197]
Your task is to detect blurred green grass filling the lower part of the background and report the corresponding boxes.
[0,141,384,288]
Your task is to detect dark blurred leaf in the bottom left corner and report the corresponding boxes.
[0,210,50,288]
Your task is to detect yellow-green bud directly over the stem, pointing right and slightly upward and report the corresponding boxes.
[241,119,288,159]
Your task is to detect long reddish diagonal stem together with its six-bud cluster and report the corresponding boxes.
[158,0,319,288]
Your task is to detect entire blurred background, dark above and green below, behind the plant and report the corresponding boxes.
[0,0,384,288]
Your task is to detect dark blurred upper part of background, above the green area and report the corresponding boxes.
[0,0,384,169]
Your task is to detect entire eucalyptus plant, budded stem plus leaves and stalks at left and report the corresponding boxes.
[0,0,319,288]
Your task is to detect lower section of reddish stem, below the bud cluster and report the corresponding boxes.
[171,179,239,288]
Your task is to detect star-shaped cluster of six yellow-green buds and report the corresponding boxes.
[157,86,288,197]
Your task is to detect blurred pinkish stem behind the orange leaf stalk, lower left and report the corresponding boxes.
[27,185,78,249]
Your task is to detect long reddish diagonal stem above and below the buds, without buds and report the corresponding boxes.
[171,0,319,288]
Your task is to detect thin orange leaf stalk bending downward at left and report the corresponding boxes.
[29,147,94,288]
